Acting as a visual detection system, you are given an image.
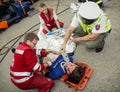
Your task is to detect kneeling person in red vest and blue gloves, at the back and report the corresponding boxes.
[39,3,64,35]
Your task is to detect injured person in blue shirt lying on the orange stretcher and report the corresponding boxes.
[43,50,85,84]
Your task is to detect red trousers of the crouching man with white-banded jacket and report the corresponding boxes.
[12,74,54,92]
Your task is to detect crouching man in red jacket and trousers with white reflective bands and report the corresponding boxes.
[10,33,54,92]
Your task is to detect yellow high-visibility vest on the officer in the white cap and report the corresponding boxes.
[77,14,112,35]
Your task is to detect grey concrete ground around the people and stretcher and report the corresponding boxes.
[0,0,120,92]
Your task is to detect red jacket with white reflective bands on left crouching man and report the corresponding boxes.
[10,42,44,84]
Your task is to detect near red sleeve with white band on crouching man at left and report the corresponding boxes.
[24,50,45,72]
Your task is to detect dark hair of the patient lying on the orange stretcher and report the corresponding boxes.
[67,66,85,84]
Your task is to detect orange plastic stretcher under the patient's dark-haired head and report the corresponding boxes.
[60,62,93,90]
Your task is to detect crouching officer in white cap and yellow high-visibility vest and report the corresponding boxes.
[61,1,111,52]
